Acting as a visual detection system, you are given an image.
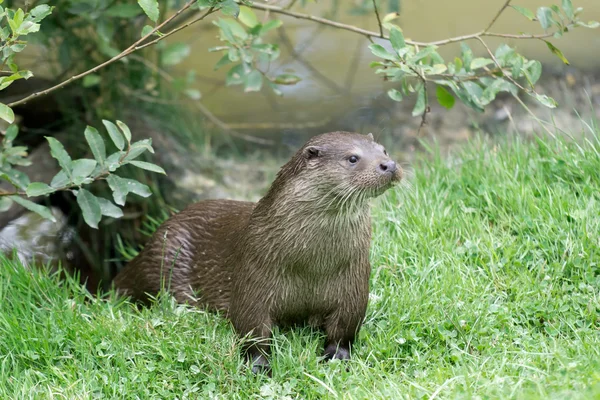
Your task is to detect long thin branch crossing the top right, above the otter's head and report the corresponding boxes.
[248,3,553,47]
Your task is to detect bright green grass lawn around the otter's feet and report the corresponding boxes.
[0,133,600,399]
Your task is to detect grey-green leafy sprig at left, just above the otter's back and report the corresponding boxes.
[0,121,165,228]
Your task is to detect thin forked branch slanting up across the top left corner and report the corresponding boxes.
[8,0,214,107]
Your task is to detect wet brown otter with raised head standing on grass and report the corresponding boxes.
[114,132,402,375]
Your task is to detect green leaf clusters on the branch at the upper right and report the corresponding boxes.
[369,0,600,116]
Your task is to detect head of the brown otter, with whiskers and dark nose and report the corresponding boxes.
[290,132,402,204]
